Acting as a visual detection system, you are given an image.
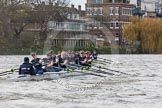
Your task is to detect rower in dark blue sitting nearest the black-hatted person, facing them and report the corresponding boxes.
[31,52,44,74]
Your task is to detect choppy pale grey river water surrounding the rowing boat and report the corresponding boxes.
[0,55,162,108]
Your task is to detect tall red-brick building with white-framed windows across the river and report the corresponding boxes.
[86,0,135,44]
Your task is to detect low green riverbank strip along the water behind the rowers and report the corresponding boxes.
[0,46,127,55]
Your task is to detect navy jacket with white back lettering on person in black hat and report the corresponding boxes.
[19,63,35,75]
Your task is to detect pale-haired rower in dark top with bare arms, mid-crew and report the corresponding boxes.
[59,51,68,68]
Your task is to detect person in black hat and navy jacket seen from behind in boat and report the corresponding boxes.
[19,57,36,75]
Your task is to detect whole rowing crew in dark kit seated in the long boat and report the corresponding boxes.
[19,50,97,75]
